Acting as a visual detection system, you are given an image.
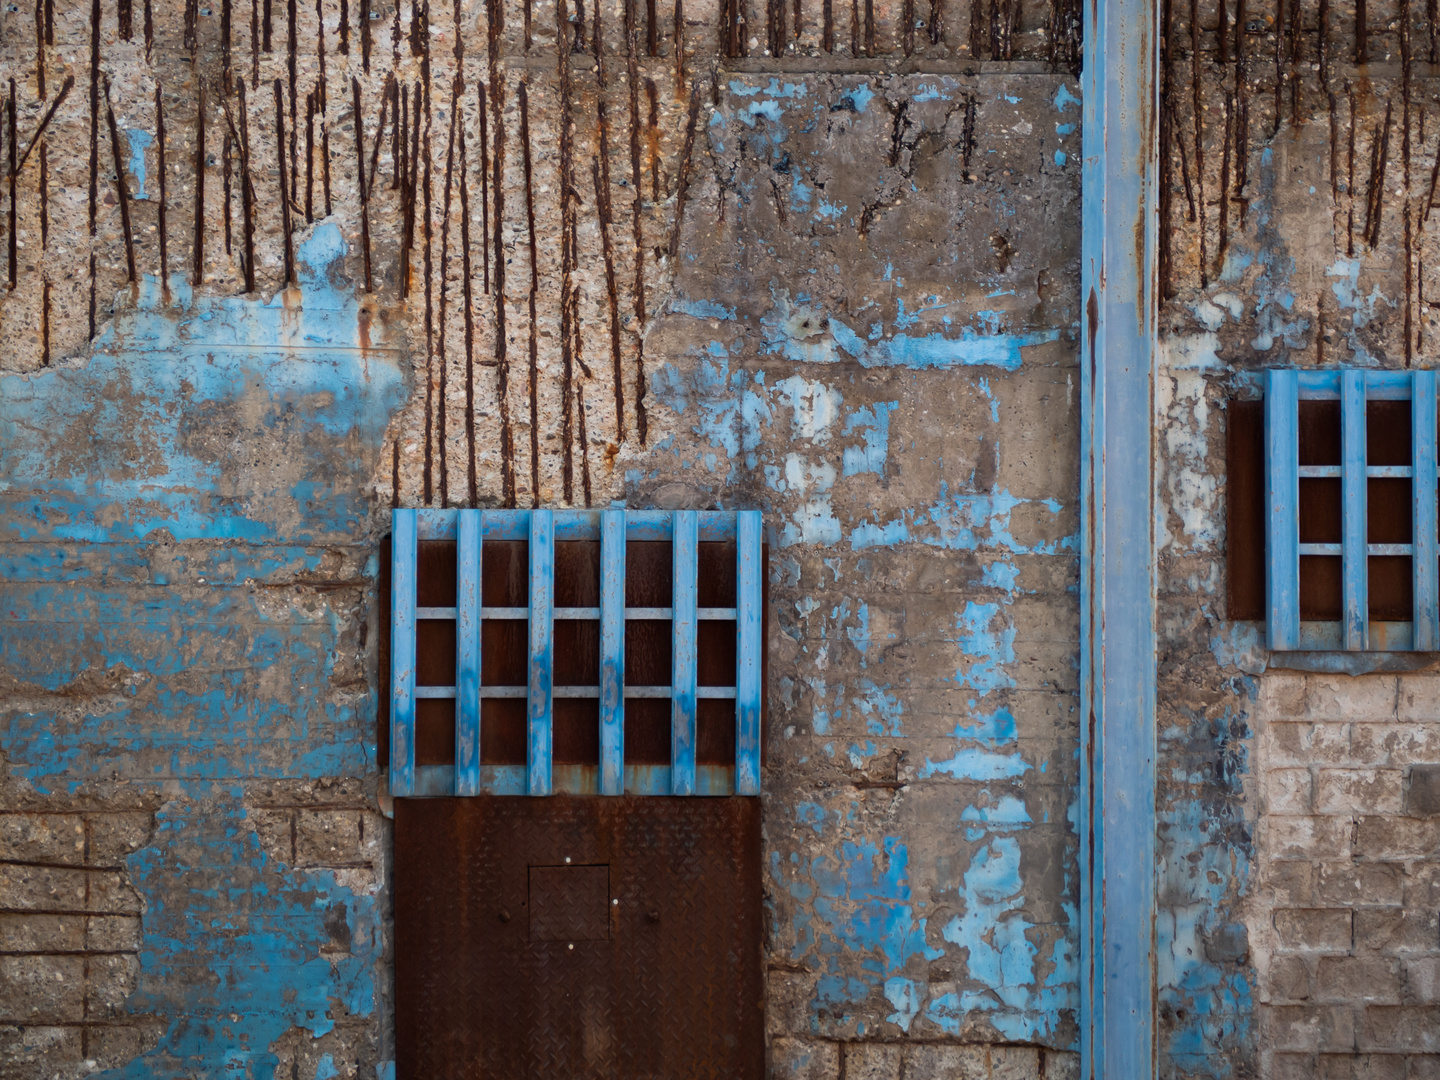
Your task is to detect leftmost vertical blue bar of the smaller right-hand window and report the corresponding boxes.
[1264,370,1300,649]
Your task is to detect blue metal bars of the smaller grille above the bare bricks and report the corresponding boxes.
[1264,369,1440,651]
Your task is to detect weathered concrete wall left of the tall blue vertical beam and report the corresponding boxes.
[0,0,1080,1080]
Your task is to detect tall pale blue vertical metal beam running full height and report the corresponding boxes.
[1080,0,1159,1080]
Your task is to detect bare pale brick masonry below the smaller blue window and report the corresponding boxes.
[1247,674,1440,1077]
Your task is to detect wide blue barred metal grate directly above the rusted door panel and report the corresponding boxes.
[389,510,763,796]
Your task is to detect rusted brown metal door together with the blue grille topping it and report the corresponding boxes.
[389,510,765,1080]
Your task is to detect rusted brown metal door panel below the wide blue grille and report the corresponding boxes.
[395,796,765,1080]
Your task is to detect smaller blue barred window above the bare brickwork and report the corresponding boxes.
[1264,369,1440,652]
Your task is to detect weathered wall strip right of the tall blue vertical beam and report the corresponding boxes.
[1156,3,1440,1077]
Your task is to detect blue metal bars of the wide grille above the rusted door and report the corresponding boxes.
[390,510,763,796]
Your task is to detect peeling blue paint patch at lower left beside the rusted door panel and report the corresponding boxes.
[95,799,384,1080]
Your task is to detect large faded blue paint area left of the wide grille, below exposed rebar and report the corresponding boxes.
[0,223,405,788]
